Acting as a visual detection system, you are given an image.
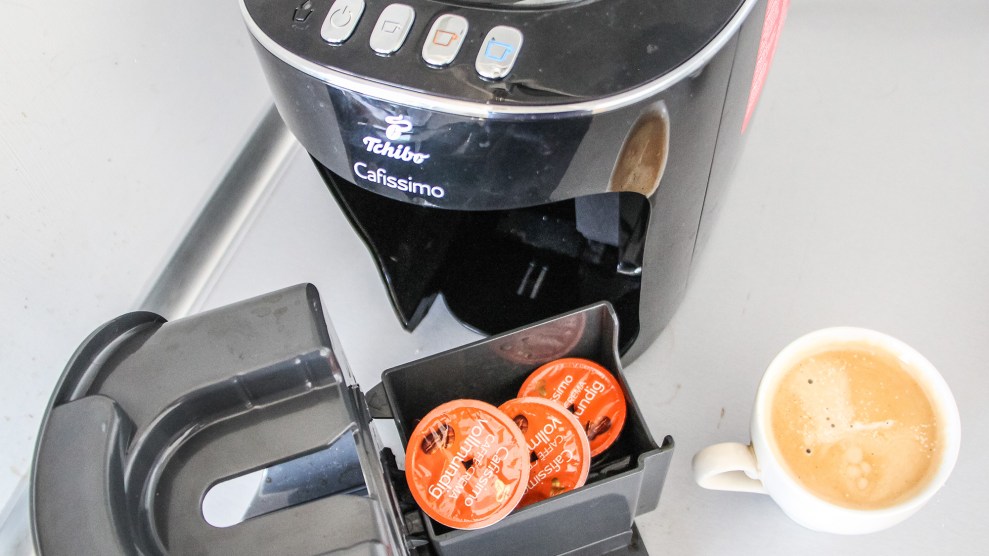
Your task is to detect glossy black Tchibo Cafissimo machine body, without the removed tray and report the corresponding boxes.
[241,0,766,362]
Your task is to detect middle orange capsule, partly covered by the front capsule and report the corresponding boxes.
[498,397,591,507]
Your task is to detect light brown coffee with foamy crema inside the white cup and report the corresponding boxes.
[771,345,941,510]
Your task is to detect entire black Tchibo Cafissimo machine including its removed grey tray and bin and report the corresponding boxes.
[31,0,766,556]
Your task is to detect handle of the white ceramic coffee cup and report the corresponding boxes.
[693,442,766,494]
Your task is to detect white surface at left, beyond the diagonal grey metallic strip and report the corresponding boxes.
[0,0,270,507]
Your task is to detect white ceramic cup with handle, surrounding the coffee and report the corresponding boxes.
[693,327,961,534]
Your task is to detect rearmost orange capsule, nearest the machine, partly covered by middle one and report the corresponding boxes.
[519,357,626,456]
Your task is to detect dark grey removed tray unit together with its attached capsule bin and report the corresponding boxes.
[31,285,673,555]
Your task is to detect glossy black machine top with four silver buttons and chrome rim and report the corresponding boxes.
[241,0,757,117]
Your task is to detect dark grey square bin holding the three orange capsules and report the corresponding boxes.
[368,303,673,555]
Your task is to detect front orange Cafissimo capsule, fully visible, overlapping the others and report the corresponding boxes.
[405,400,529,529]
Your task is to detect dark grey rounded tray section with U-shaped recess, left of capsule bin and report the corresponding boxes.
[31,285,404,556]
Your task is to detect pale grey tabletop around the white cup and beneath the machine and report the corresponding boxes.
[0,0,989,554]
